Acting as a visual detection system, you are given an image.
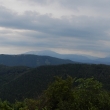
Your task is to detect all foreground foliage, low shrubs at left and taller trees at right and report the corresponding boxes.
[0,77,110,110]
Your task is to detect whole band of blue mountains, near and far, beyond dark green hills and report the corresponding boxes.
[0,50,110,67]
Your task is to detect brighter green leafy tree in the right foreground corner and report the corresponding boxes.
[74,78,110,110]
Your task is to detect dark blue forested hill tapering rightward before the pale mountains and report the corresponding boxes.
[0,54,75,67]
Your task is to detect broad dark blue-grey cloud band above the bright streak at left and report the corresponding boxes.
[0,7,110,39]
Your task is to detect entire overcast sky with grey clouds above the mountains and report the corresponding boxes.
[0,0,110,57]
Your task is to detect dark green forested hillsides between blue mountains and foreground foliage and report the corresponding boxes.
[0,64,110,101]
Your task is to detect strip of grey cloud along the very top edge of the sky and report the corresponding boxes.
[18,0,110,9]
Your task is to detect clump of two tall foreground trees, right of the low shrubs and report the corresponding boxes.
[40,77,110,110]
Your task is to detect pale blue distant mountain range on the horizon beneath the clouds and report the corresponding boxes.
[25,50,110,65]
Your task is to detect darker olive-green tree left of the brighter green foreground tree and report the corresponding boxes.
[45,77,74,110]
